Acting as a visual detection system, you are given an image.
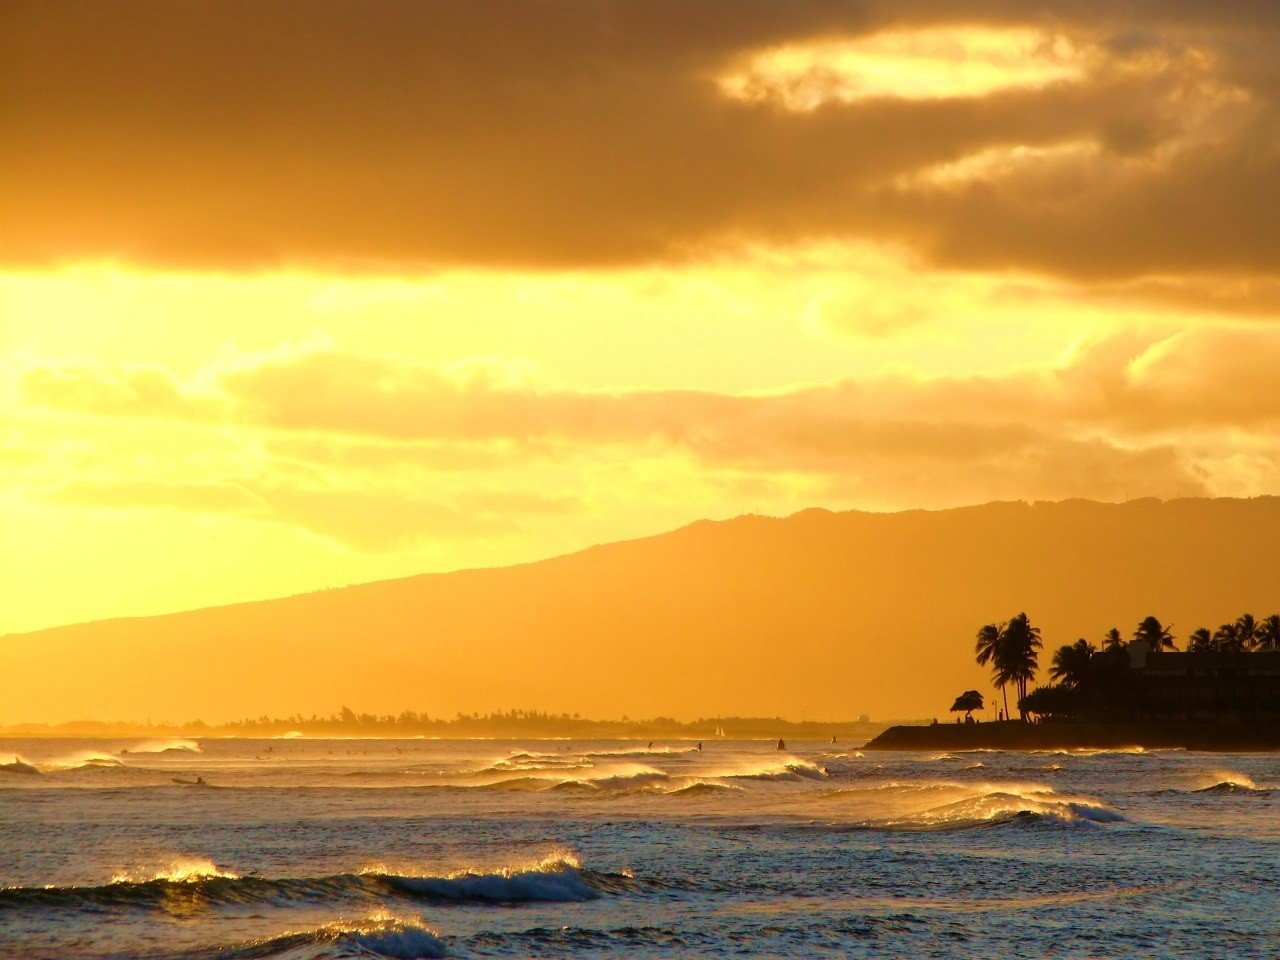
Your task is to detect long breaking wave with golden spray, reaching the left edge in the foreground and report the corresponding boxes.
[0,854,640,911]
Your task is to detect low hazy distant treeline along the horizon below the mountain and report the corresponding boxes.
[0,707,890,740]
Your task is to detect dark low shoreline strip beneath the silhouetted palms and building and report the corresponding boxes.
[861,721,1280,753]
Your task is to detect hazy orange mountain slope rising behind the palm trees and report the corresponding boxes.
[0,497,1280,722]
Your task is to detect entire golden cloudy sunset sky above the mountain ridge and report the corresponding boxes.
[0,0,1280,632]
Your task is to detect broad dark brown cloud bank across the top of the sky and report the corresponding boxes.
[0,0,1280,282]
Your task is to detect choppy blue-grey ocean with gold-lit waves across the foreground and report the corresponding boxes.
[0,740,1280,960]
